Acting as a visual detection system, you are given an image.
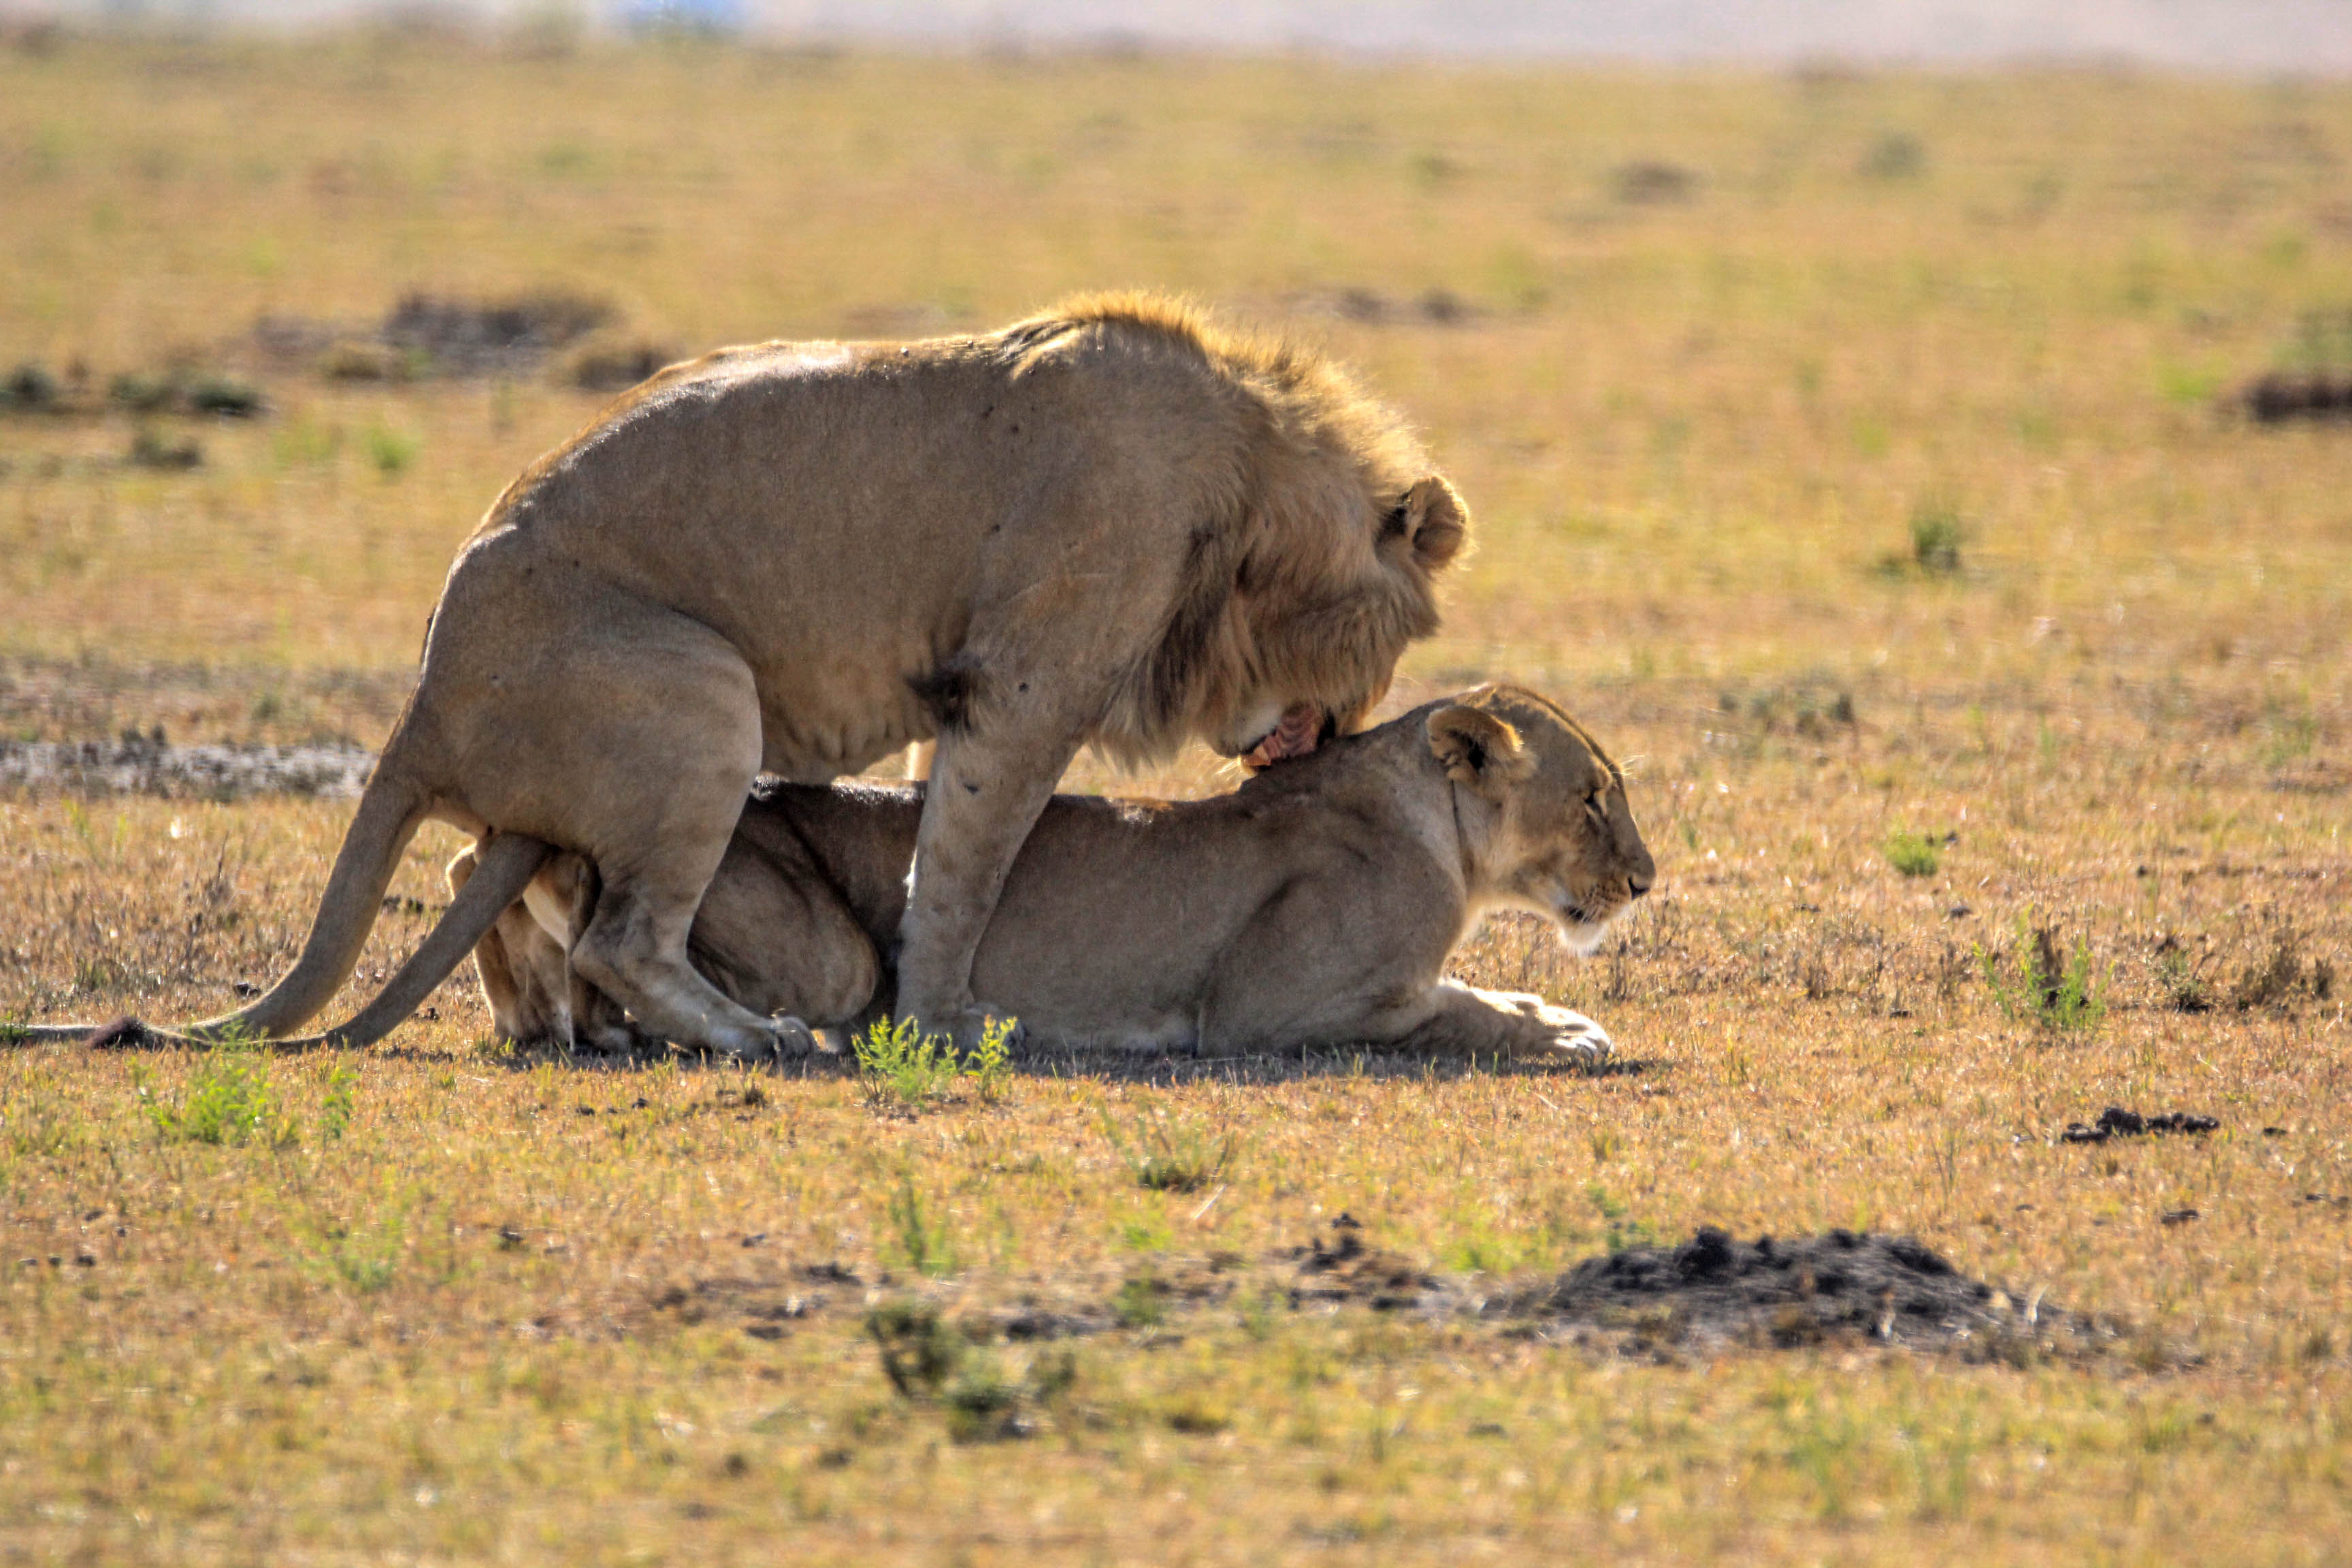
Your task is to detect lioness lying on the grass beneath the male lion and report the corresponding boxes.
[452,687,1654,1060]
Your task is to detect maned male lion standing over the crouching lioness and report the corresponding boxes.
[22,296,1468,1056]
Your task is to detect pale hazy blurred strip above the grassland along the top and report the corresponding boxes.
[14,0,2352,76]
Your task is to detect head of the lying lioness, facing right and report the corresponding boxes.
[1428,687,1658,952]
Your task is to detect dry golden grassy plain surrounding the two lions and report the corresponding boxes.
[0,27,2352,1563]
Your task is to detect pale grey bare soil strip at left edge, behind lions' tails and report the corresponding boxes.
[0,731,376,802]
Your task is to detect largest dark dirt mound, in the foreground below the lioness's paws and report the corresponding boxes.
[1510,1227,2098,1354]
